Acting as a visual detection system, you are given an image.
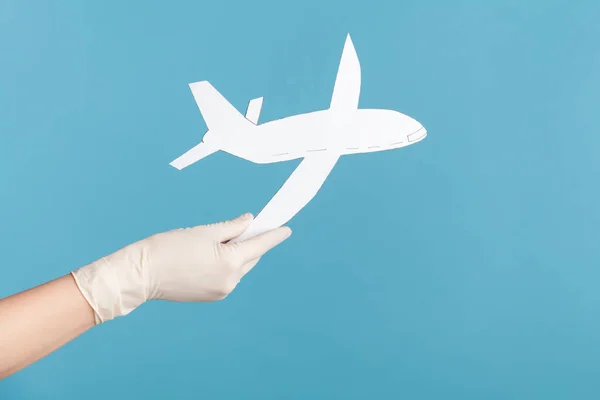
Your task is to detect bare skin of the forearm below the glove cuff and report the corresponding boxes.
[0,274,95,379]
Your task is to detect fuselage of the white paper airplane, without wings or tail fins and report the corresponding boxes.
[209,109,427,164]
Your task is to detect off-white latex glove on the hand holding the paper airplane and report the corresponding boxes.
[72,214,291,324]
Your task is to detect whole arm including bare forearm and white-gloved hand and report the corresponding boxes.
[0,214,291,379]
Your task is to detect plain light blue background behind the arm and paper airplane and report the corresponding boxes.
[0,0,600,399]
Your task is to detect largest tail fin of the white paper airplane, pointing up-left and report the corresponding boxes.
[190,81,254,135]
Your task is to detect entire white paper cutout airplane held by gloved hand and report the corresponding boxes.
[171,35,427,241]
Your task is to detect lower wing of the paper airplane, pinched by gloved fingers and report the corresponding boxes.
[232,152,340,242]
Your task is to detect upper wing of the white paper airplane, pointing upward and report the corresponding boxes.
[329,35,361,111]
